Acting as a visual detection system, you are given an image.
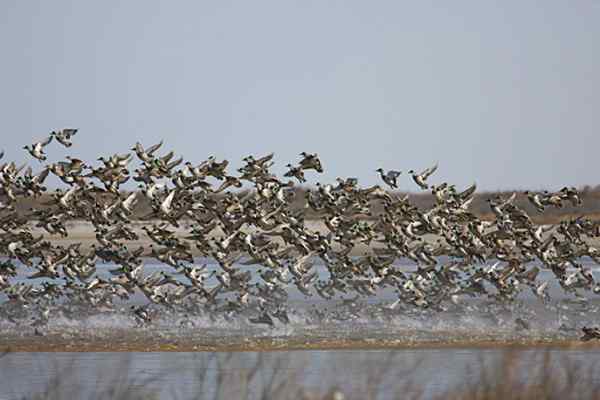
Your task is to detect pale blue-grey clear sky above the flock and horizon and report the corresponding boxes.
[0,0,600,190]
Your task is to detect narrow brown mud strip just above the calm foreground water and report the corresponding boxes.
[0,333,600,352]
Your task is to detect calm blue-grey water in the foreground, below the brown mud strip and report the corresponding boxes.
[0,348,600,399]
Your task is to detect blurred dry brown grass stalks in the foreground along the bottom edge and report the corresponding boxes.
[0,350,600,400]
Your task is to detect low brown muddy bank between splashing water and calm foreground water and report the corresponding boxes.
[0,328,600,352]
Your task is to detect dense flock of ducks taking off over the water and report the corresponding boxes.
[0,129,600,338]
